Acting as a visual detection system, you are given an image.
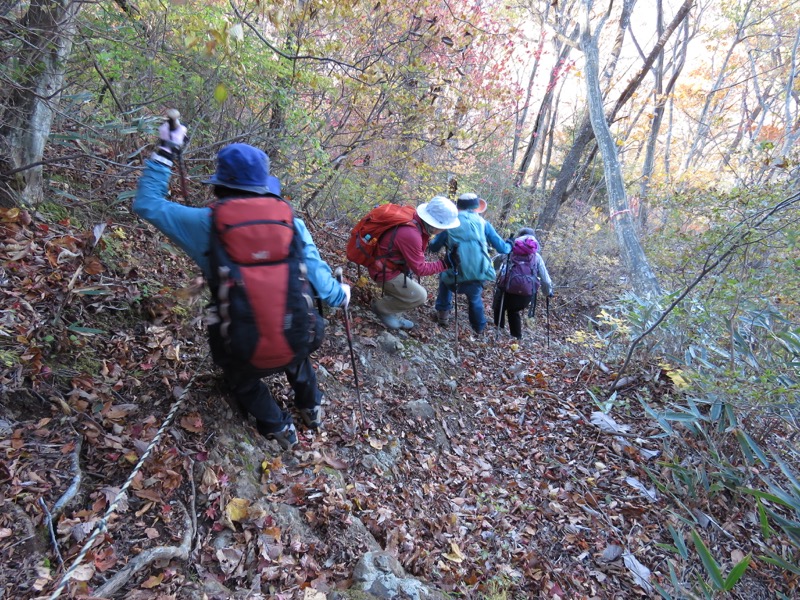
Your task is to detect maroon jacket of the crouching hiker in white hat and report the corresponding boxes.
[369,212,447,283]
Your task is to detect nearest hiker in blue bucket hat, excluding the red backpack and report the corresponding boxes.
[133,117,350,449]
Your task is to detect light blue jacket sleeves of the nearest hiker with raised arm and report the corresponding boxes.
[133,160,345,306]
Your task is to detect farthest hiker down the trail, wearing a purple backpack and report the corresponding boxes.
[492,227,553,339]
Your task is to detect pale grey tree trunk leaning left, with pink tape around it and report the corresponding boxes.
[581,0,661,297]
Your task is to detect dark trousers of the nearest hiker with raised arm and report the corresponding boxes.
[209,336,322,435]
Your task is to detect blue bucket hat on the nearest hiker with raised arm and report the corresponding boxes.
[203,144,281,196]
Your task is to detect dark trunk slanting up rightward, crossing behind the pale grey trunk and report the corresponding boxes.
[536,0,695,237]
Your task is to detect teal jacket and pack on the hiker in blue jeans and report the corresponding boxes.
[428,210,511,285]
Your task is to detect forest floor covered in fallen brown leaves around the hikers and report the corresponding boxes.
[0,202,797,600]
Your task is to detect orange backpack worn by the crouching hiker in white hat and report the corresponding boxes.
[347,204,416,268]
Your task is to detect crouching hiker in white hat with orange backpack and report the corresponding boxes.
[347,196,459,329]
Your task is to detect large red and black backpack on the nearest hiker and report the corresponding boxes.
[208,195,325,371]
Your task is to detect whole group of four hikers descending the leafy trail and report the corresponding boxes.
[133,117,553,450]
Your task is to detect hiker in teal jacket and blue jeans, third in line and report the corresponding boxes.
[428,194,511,333]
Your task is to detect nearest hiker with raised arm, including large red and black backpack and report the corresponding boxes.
[133,115,350,450]
